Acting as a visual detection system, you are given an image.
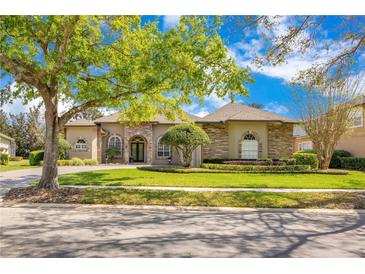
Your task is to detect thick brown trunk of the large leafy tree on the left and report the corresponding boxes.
[38,96,59,189]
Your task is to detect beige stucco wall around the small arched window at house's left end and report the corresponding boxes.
[66,126,97,160]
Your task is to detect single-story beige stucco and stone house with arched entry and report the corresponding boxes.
[65,103,297,166]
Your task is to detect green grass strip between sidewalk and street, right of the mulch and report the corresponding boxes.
[81,189,365,209]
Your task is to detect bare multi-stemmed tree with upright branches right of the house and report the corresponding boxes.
[295,74,365,169]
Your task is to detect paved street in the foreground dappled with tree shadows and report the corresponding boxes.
[0,204,365,257]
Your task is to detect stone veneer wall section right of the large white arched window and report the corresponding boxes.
[267,123,294,158]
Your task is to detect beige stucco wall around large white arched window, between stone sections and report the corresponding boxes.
[227,121,268,159]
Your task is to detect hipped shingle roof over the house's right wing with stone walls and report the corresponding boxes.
[197,103,297,123]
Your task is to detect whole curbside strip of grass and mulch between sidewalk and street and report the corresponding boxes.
[4,187,365,209]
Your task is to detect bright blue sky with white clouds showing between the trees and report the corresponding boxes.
[0,16,365,118]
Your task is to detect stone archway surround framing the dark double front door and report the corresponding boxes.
[123,124,153,164]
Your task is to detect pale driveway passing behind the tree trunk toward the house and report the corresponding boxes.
[0,165,141,197]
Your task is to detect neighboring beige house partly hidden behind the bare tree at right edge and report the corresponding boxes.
[293,96,365,157]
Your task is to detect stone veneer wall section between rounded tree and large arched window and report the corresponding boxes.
[202,124,228,159]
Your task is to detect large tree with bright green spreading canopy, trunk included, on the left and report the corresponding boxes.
[0,16,252,189]
